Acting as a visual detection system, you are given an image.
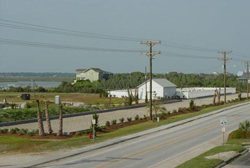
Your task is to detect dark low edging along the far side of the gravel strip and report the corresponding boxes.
[0,100,182,127]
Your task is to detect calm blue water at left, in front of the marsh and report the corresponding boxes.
[0,81,61,89]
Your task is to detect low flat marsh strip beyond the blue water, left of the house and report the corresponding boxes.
[0,77,75,82]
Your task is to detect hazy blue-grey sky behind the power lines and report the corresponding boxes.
[0,0,250,74]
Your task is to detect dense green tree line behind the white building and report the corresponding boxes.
[1,72,246,94]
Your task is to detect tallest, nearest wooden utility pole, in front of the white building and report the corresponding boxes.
[141,41,161,121]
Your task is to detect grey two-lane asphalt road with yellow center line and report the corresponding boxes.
[35,105,250,168]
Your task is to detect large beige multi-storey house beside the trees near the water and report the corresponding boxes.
[74,68,113,83]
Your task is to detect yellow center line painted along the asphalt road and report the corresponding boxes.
[96,113,245,168]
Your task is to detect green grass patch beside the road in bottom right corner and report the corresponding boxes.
[176,139,250,168]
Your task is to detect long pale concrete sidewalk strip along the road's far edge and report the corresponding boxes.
[17,102,250,168]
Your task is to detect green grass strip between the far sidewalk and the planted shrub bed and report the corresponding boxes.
[0,102,249,154]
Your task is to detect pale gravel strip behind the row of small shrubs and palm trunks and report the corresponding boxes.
[2,94,246,132]
